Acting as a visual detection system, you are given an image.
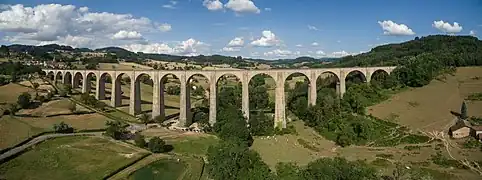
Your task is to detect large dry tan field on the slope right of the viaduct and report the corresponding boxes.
[368,67,482,131]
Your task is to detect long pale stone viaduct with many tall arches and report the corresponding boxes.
[43,67,395,128]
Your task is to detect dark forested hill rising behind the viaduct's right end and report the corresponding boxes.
[327,35,482,67]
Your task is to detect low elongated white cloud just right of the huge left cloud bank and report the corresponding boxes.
[123,38,208,56]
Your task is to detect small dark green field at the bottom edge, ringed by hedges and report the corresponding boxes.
[130,159,187,180]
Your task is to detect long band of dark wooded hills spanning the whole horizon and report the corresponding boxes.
[2,35,482,68]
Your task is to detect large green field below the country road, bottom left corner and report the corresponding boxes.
[0,137,148,180]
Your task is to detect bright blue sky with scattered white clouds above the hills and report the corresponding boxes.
[0,0,482,59]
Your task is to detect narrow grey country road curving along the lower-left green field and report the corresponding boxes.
[0,132,102,162]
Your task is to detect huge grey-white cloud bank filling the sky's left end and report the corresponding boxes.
[0,4,166,48]
